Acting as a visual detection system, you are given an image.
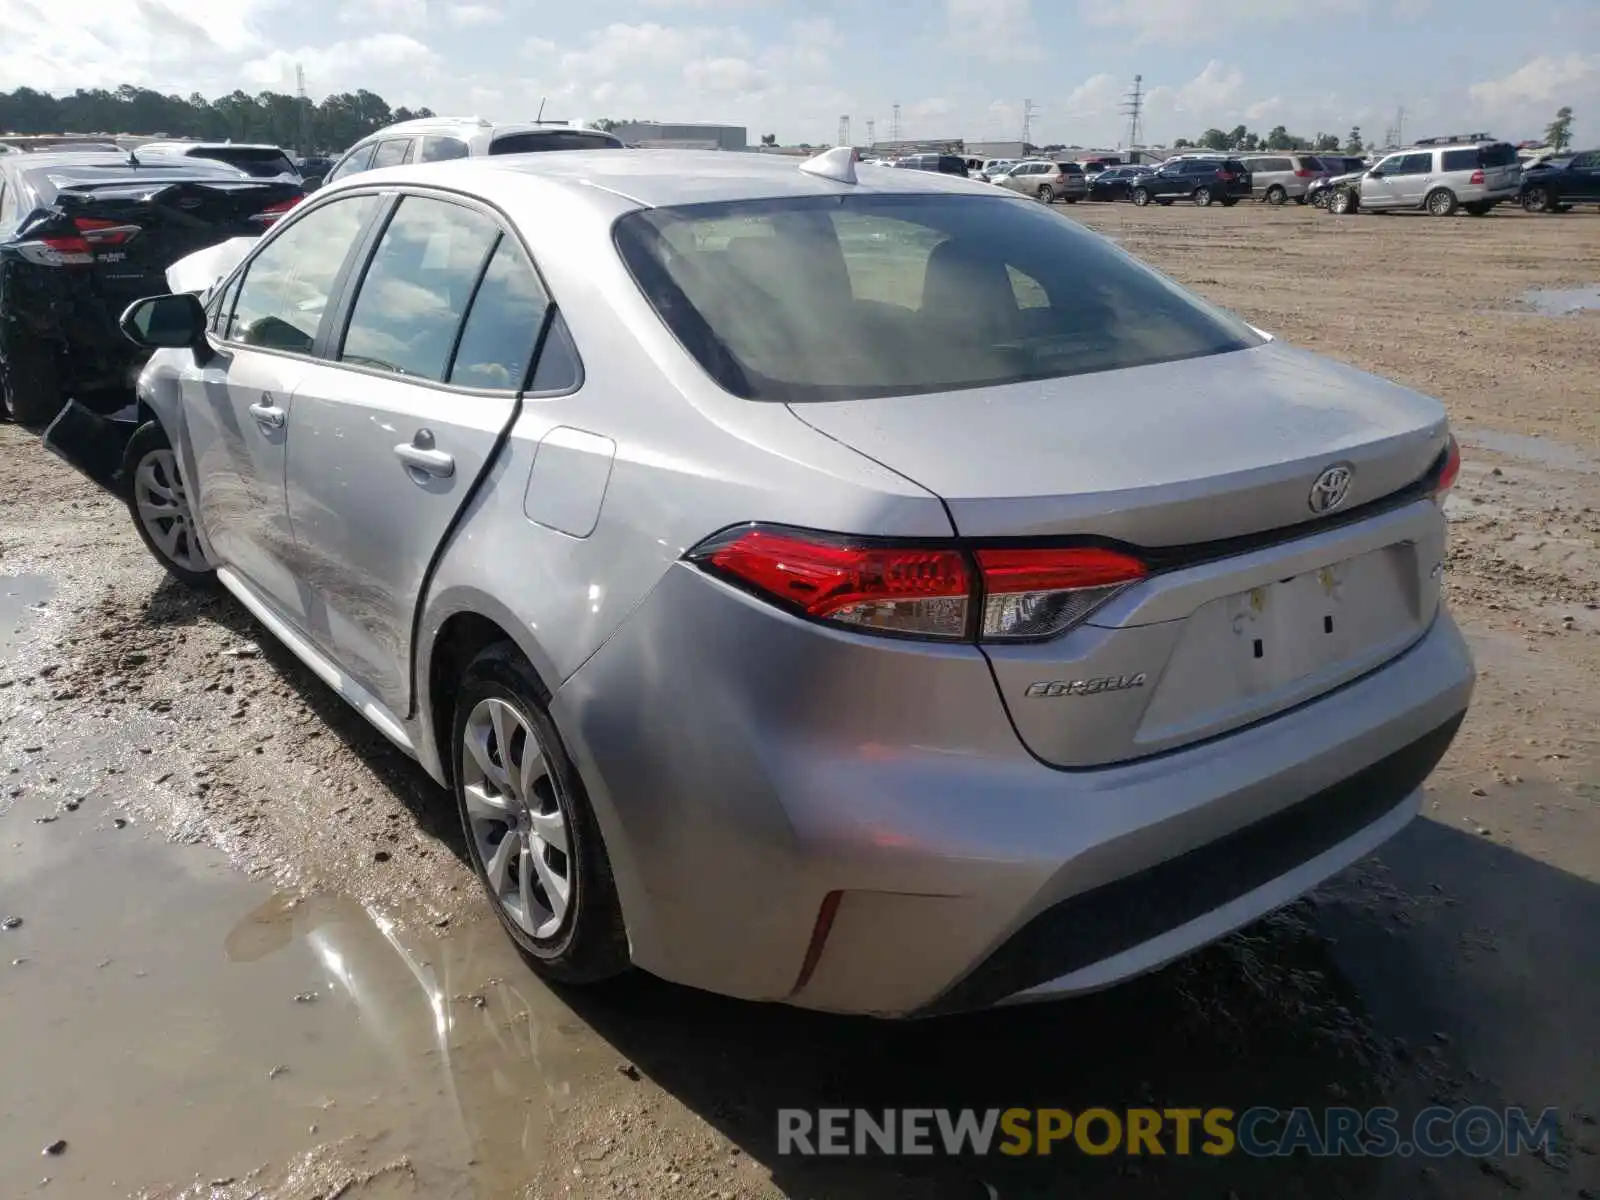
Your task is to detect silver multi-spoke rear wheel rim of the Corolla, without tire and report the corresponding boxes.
[461,698,574,939]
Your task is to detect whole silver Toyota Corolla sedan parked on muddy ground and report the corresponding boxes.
[112,150,1474,1014]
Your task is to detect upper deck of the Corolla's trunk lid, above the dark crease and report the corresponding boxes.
[790,342,1446,547]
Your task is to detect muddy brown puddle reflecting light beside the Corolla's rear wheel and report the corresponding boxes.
[0,812,611,1200]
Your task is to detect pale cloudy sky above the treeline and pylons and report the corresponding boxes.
[0,0,1600,149]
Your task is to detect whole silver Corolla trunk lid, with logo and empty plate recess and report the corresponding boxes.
[794,342,1448,766]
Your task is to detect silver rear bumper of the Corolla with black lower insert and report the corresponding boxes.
[552,566,1474,1016]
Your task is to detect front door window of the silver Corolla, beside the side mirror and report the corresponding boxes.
[222,195,379,354]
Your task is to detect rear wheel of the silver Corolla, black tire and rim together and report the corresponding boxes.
[451,642,630,984]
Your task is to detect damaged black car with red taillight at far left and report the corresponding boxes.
[0,150,304,426]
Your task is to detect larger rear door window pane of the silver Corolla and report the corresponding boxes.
[339,195,499,381]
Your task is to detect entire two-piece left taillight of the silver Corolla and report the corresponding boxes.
[688,525,1147,642]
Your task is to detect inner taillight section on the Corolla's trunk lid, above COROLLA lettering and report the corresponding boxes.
[978,547,1149,642]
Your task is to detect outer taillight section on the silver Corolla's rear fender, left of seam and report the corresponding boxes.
[691,528,973,638]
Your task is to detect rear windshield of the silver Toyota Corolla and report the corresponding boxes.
[616,195,1261,402]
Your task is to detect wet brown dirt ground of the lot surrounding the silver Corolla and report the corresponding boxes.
[0,205,1600,1200]
